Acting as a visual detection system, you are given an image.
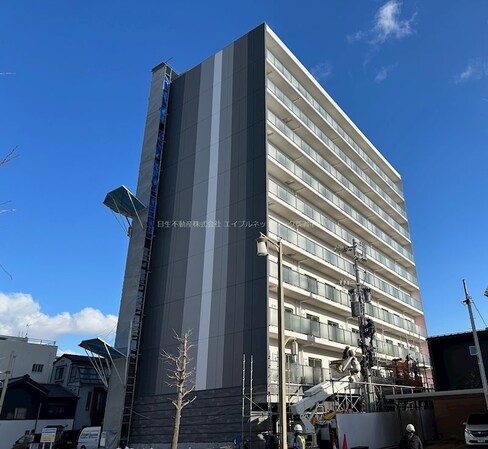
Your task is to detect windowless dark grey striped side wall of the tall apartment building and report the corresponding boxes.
[126,22,268,444]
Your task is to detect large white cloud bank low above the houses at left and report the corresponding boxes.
[0,292,117,340]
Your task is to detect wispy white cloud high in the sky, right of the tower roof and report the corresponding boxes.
[347,0,416,45]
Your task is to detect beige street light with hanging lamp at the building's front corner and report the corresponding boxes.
[256,233,288,449]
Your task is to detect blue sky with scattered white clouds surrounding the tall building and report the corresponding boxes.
[0,0,488,350]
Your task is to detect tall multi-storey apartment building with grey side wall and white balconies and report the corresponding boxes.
[104,24,428,447]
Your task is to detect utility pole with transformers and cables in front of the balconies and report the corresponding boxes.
[337,239,374,411]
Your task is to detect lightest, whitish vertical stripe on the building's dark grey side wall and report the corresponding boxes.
[195,51,222,390]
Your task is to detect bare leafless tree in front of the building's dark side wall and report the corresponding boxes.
[161,330,196,449]
